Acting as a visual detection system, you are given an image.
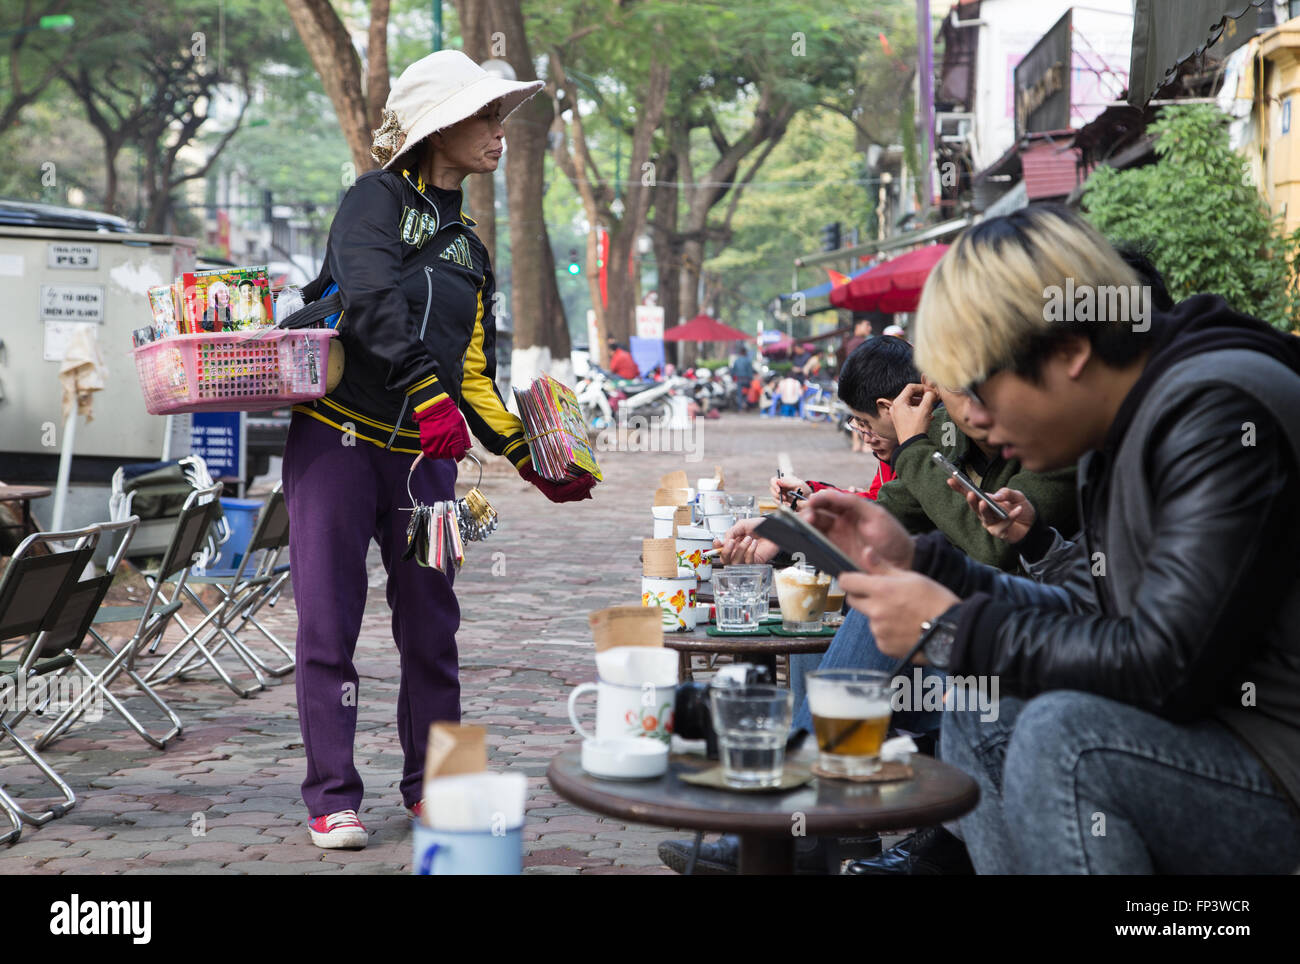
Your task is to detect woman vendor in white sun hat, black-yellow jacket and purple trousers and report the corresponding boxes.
[283,51,595,848]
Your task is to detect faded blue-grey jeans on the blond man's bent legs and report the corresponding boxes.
[940,690,1300,874]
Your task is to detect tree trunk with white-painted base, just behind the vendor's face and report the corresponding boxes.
[489,0,572,385]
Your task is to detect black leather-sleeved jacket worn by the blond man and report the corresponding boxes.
[914,342,1300,805]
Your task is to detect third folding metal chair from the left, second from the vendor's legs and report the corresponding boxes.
[134,483,267,698]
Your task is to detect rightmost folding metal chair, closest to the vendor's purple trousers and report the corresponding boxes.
[159,482,294,682]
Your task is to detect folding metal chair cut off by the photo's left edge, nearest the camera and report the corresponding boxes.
[0,526,99,841]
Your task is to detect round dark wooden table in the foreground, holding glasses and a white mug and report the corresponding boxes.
[546,747,979,874]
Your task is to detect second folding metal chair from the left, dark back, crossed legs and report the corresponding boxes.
[20,516,192,750]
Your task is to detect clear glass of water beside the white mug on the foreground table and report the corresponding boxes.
[709,685,794,787]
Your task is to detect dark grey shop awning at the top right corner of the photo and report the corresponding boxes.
[1128,0,1266,107]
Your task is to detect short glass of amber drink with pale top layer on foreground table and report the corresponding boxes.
[807,669,892,777]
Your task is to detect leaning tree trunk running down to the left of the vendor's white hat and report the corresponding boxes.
[285,0,389,174]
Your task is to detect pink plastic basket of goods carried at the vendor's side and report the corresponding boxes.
[131,329,338,414]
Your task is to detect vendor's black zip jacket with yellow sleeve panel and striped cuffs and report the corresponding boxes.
[294,170,528,465]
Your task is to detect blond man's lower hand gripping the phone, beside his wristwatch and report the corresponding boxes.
[840,551,961,663]
